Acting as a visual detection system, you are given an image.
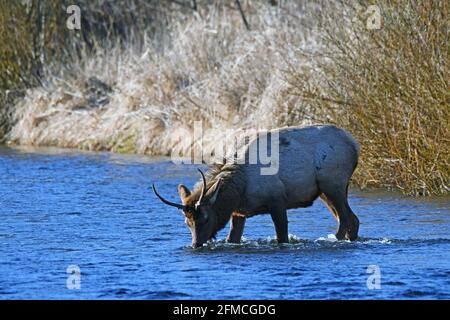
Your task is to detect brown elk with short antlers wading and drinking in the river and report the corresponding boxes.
[153,125,359,247]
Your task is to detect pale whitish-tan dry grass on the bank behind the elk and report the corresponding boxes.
[9,2,316,155]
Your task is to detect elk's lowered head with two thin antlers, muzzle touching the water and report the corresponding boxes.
[153,169,221,248]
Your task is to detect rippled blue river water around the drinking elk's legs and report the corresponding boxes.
[0,147,450,299]
